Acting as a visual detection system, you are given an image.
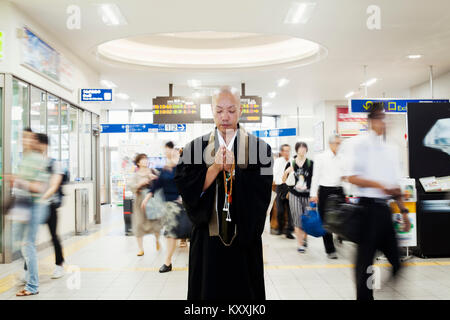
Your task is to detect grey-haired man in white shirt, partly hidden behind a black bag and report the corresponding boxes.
[310,134,345,259]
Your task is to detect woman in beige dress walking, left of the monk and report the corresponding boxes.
[128,153,161,256]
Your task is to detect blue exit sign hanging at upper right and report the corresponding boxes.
[350,99,448,113]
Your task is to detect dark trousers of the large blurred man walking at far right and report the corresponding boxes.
[356,198,400,300]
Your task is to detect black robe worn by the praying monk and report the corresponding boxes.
[175,129,273,300]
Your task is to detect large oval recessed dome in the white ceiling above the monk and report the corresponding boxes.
[97,31,327,69]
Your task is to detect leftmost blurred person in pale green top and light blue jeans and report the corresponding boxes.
[5,128,50,297]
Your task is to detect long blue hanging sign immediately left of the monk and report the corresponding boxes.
[101,123,186,133]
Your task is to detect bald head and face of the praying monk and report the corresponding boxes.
[213,92,242,133]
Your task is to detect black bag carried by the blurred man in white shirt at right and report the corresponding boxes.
[323,195,364,243]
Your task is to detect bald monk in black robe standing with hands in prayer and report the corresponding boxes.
[175,88,273,300]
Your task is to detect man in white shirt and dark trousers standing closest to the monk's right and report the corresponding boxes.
[273,144,295,239]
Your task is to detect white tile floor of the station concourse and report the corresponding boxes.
[0,206,450,300]
